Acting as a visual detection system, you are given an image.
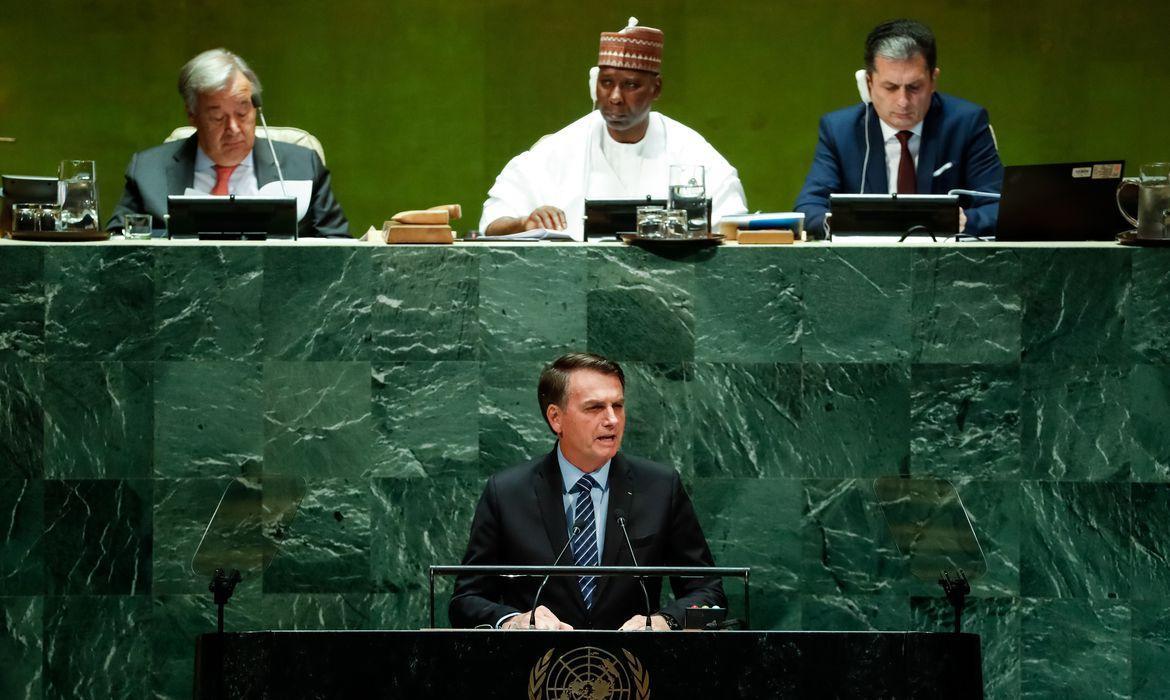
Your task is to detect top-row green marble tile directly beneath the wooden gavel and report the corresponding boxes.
[376,246,481,361]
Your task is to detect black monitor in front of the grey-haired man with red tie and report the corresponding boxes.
[166,194,297,241]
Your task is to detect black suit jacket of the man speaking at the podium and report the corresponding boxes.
[448,449,727,630]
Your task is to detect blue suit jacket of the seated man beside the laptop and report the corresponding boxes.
[796,92,1004,234]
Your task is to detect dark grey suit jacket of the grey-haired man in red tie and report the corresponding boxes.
[105,135,350,238]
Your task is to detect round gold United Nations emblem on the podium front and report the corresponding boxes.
[528,646,651,700]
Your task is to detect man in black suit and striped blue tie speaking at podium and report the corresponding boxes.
[448,354,727,630]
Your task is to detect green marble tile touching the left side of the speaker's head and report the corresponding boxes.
[480,359,556,474]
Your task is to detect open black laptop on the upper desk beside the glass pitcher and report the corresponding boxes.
[996,160,1131,241]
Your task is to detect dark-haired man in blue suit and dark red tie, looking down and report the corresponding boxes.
[796,20,1004,235]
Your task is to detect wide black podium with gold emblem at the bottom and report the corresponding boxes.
[194,630,983,700]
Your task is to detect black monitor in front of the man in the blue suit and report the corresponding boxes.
[828,194,958,236]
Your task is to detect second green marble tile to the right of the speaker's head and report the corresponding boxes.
[690,363,805,478]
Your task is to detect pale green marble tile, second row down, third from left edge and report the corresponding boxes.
[154,362,264,476]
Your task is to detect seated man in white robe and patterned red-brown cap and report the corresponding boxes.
[480,18,748,240]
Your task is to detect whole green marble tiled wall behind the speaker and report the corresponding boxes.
[0,245,1170,698]
